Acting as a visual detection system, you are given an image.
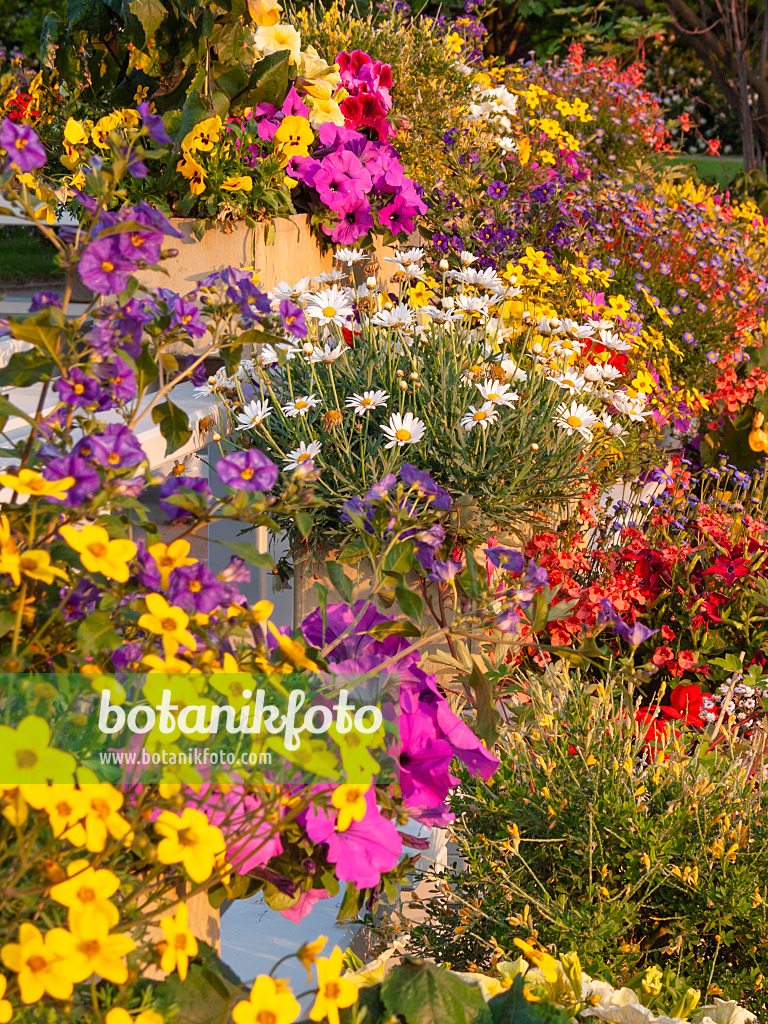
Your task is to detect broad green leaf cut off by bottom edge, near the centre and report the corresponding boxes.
[381,956,493,1024]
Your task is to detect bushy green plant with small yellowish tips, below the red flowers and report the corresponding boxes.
[414,665,768,1010]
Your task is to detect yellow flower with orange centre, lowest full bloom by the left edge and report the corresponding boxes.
[0,921,73,1004]
